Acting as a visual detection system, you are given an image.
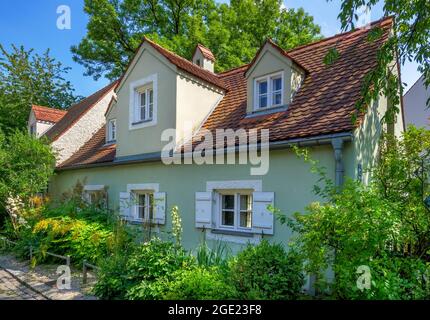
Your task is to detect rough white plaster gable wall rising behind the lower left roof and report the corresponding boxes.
[52,90,113,165]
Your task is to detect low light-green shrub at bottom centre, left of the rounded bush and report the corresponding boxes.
[163,267,237,300]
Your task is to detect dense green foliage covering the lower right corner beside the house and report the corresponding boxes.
[281,127,430,299]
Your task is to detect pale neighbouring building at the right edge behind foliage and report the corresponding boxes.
[403,76,430,129]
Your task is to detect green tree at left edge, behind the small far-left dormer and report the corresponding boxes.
[0,45,80,134]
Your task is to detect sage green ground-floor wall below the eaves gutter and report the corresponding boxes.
[50,145,342,250]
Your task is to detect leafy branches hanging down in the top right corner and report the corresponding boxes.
[327,0,430,121]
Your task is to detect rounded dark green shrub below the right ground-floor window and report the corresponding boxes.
[230,240,304,300]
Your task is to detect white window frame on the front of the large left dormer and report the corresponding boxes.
[129,74,158,130]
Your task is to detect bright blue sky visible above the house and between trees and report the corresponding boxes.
[0,0,419,96]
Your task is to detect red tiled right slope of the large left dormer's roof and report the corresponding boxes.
[144,38,227,89]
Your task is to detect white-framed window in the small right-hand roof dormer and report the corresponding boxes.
[254,73,284,110]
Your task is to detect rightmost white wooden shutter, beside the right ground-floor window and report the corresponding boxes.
[252,192,275,234]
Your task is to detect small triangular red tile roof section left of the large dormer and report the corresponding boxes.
[57,126,116,169]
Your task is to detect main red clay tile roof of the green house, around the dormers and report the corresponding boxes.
[56,18,392,168]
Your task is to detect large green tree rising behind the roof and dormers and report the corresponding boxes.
[71,0,320,79]
